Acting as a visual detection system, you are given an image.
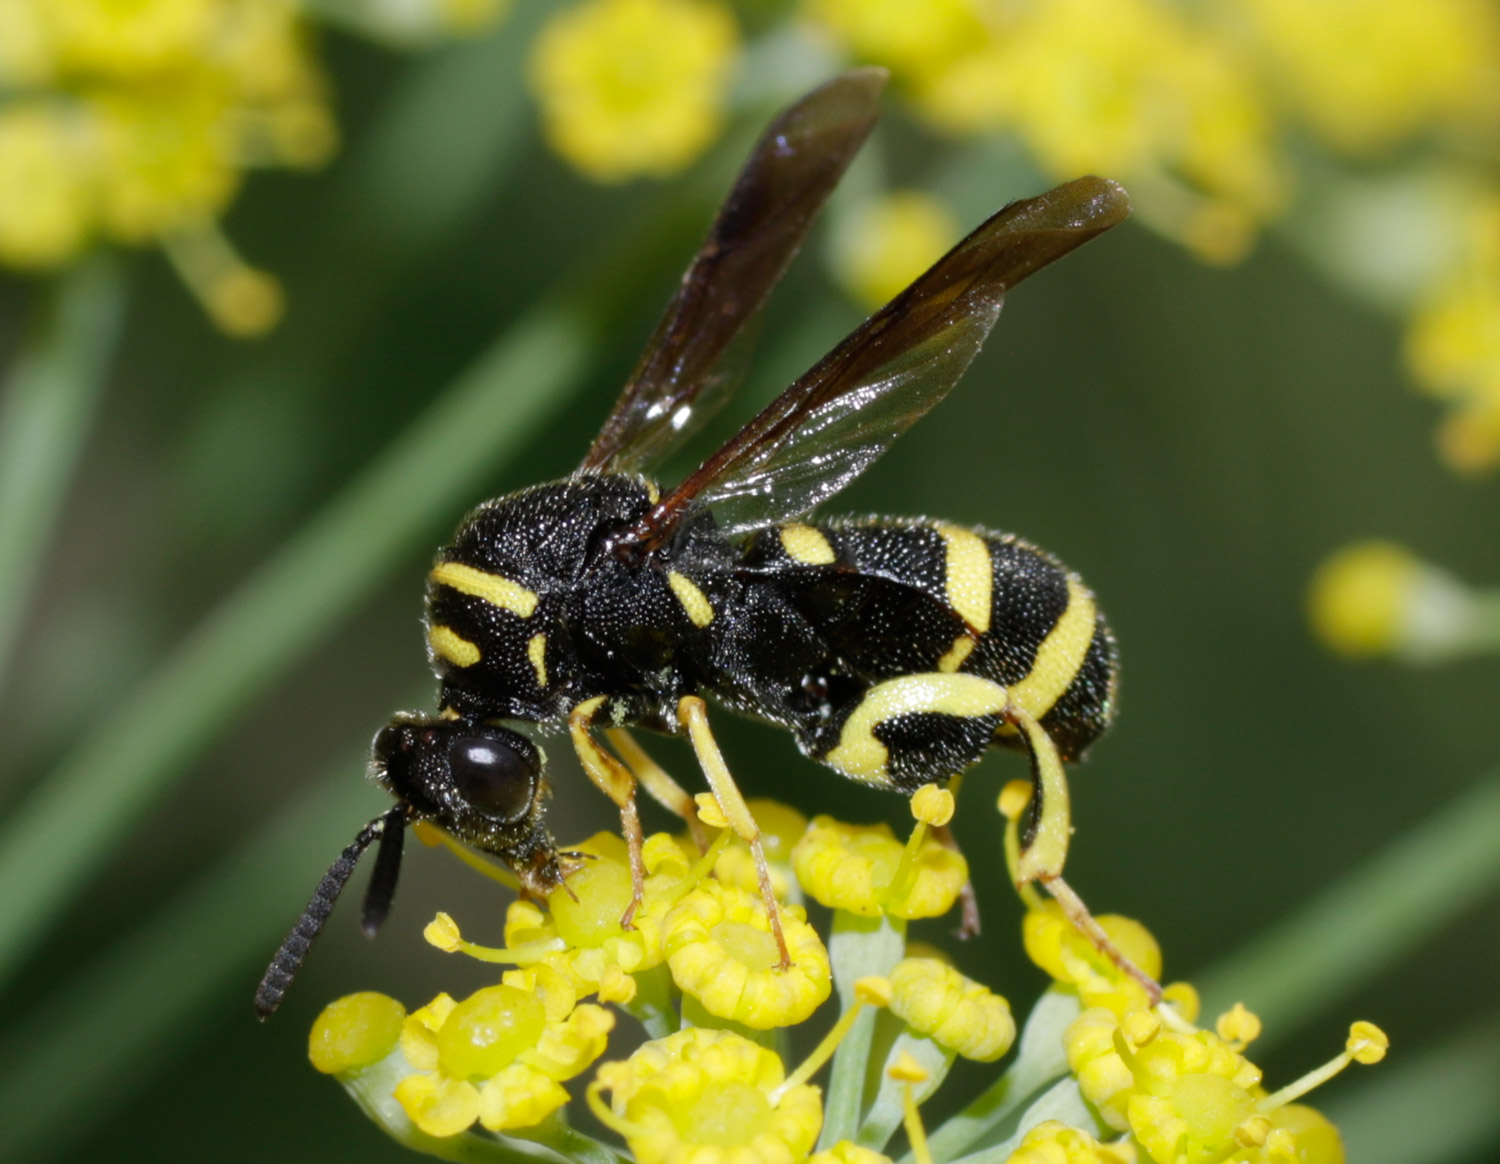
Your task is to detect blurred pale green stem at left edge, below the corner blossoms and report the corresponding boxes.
[0,255,125,696]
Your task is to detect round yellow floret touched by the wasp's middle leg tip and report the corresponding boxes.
[662,881,833,1031]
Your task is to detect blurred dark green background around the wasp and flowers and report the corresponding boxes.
[0,3,1500,1164]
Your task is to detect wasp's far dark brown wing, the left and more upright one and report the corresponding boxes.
[581,69,885,473]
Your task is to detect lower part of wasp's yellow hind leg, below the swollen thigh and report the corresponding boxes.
[1005,704,1161,1007]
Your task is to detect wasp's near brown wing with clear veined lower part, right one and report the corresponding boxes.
[627,177,1130,551]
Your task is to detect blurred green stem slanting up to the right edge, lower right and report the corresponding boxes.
[1199,774,1500,1050]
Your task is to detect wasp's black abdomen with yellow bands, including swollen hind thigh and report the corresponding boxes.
[746,518,1116,791]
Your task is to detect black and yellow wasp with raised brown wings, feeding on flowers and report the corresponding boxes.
[257,69,1130,1016]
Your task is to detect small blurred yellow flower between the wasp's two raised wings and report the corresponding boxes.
[833,191,959,309]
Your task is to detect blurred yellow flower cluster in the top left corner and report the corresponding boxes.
[0,0,335,333]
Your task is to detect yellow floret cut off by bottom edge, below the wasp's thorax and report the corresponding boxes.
[590,1028,824,1164]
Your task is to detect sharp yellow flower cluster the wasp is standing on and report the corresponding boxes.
[309,785,1386,1164]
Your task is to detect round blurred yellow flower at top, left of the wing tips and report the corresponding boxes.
[531,0,740,182]
